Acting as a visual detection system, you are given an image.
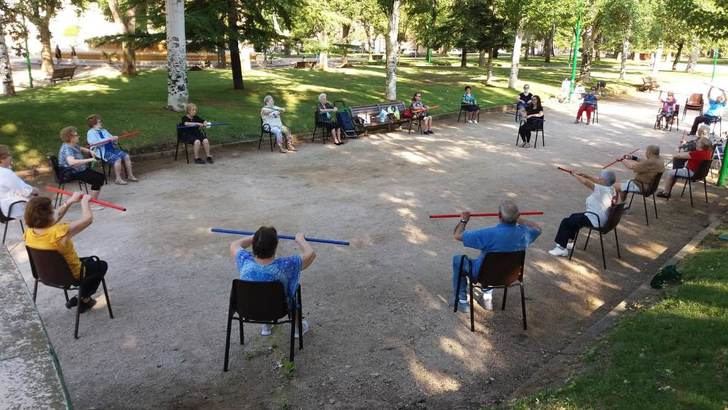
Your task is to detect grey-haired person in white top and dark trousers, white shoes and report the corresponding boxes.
[549,170,617,256]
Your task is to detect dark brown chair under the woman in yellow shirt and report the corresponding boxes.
[25,246,114,339]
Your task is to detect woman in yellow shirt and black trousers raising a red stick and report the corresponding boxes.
[24,192,108,313]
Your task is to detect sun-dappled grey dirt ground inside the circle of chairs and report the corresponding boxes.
[11,94,728,409]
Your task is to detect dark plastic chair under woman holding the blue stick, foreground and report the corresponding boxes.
[223,279,303,371]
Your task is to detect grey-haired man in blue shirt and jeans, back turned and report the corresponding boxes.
[452,200,541,312]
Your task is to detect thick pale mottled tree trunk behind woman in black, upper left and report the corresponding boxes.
[165,0,189,111]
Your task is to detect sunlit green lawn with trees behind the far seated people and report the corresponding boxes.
[0,55,707,168]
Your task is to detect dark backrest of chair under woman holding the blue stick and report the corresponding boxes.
[230,279,288,321]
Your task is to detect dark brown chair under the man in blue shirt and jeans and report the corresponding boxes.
[455,250,528,332]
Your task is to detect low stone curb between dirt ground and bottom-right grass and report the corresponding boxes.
[508,219,723,401]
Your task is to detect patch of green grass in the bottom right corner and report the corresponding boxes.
[514,227,728,410]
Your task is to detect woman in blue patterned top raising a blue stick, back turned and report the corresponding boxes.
[230,226,316,336]
